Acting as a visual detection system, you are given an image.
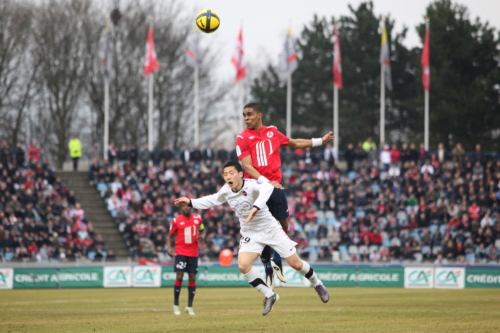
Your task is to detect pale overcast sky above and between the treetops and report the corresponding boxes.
[186,0,500,79]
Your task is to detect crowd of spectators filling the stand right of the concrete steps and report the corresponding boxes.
[89,138,500,263]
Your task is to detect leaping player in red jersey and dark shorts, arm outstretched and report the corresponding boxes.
[236,103,334,288]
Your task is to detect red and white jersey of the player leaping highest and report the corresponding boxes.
[236,126,290,183]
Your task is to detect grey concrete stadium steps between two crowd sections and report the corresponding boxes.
[57,172,129,259]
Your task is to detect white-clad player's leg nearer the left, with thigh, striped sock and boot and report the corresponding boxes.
[238,252,279,316]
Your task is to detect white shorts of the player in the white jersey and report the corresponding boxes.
[239,225,297,258]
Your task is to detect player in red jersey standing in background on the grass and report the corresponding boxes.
[167,205,205,315]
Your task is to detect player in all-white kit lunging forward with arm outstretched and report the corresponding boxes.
[174,161,330,316]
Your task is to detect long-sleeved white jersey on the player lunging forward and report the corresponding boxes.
[191,179,281,234]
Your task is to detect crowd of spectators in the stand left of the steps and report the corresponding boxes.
[0,141,114,262]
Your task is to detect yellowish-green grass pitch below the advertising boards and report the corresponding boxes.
[0,287,500,333]
